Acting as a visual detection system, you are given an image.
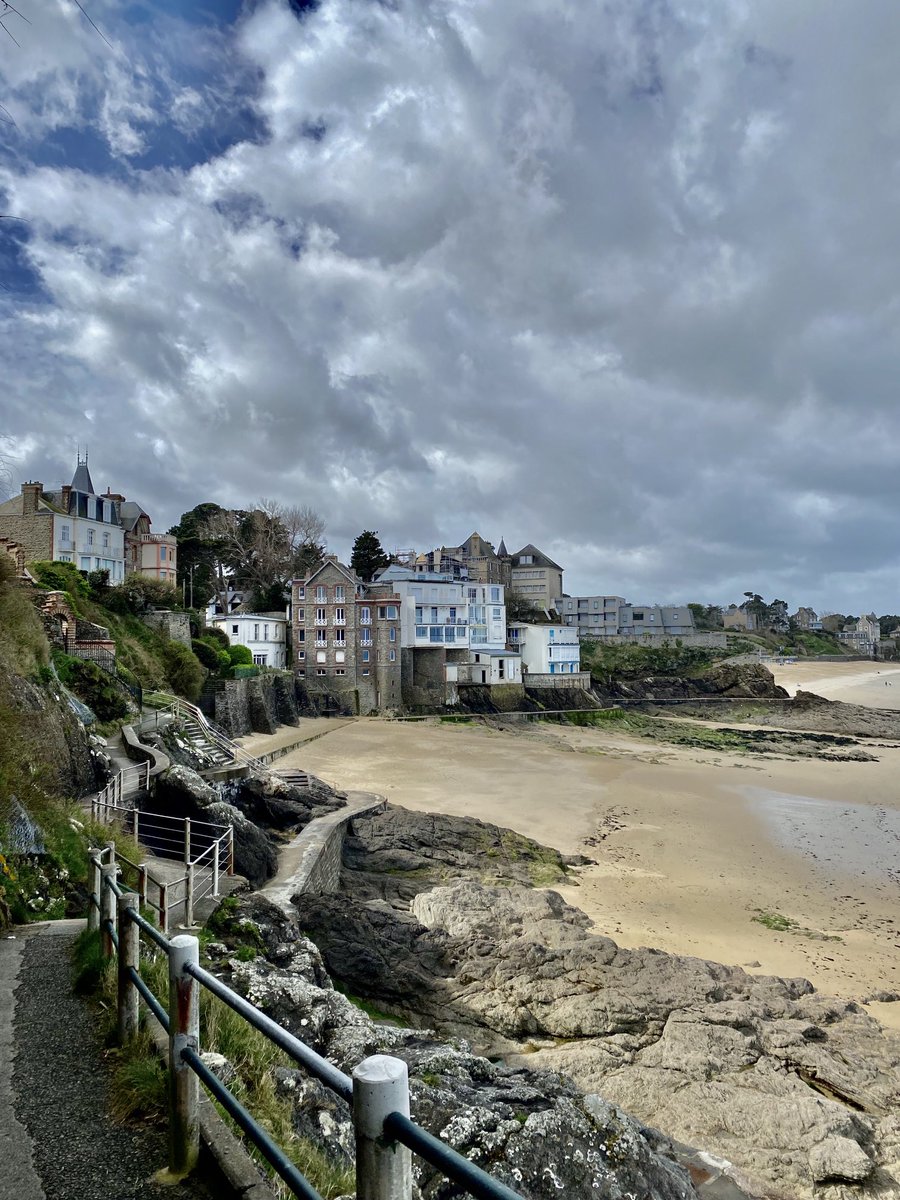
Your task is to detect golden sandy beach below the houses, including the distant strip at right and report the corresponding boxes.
[244,662,900,1027]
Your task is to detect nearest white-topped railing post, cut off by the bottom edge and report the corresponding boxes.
[353,1054,413,1200]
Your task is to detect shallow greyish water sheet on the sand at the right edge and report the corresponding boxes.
[738,787,900,884]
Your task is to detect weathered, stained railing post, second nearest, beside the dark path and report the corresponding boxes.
[169,934,200,1177]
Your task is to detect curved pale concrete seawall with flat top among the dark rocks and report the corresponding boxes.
[259,792,388,916]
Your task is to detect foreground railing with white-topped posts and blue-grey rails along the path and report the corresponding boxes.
[90,850,522,1200]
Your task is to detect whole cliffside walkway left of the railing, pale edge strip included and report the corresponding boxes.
[0,920,212,1200]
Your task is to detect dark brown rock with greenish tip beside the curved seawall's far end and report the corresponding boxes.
[341,805,571,902]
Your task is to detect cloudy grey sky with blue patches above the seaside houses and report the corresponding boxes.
[0,0,900,613]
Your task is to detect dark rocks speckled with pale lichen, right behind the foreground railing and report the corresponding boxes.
[208,896,696,1200]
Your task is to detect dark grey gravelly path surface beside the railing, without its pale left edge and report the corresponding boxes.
[12,922,212,1200]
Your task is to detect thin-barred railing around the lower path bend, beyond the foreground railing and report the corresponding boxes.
[91,811,234,932]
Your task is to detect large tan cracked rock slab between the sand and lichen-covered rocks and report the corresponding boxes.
[294,882,900,1200]
